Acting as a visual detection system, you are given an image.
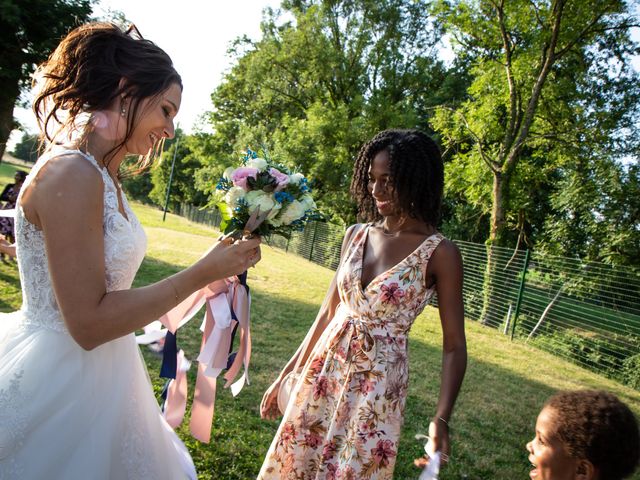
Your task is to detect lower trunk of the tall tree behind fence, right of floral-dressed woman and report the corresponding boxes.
[480,171,509,327]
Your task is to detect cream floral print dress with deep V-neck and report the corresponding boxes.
[258,224,443,480]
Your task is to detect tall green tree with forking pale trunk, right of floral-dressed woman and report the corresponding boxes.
[434,0,640,321]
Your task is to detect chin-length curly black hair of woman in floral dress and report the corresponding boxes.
[351,129,444,227]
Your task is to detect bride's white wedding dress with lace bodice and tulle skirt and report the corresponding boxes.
[0,149,196,480]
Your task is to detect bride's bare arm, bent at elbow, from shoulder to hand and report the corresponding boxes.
[22,155,259,350]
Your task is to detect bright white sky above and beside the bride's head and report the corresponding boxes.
[9,0,280,150]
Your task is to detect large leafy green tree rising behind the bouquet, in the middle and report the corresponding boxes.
[203,0,464,222]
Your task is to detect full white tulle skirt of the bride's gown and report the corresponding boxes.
[0,312,196,480]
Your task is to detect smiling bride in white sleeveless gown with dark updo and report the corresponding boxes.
[0,23,260,480]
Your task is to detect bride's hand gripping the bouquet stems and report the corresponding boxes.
[200,237,262,281]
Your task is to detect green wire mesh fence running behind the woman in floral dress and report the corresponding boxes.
[179,205,640,390]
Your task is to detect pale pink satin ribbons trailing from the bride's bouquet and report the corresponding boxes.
[160,277,251,443]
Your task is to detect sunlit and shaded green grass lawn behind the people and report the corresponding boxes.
[0,197,640,480]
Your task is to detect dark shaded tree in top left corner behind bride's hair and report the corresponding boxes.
[0,0,93,159]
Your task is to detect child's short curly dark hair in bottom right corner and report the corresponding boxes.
[545,390,640,480]
